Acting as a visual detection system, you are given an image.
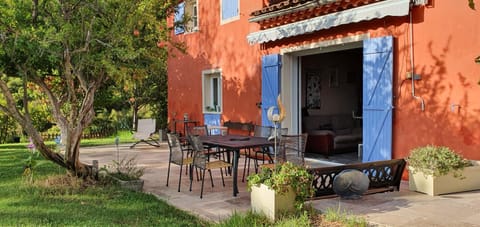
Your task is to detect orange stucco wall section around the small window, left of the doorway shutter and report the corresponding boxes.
[168,1,262,127]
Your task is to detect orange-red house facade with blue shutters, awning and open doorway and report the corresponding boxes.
[168,0,480,161]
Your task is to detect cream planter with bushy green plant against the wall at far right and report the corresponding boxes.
[406,145,480,195]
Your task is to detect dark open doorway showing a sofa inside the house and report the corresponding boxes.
[299,48,363,163]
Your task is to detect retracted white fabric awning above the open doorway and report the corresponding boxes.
[247,0,410,44]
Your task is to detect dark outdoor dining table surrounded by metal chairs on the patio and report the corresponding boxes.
[200,135,274,196]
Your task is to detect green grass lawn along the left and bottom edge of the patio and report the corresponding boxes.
[0,132,367,227]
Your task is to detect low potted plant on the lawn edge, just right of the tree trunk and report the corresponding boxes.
[100,157,145,191]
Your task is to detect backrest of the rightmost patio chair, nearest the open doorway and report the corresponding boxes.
[280,133,308,166]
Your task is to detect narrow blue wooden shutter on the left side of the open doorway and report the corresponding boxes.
[262,54,281,126]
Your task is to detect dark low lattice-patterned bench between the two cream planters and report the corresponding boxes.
[309,159,406,199]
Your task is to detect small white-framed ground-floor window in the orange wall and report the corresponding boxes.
[202,69,223,113]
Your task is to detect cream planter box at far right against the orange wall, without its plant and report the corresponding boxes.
[408,161,480,196]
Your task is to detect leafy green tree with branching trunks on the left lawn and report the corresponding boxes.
[0,0,181,177]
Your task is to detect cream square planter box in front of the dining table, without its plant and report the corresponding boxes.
[250,184,295,220]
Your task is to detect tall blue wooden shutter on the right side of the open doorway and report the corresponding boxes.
[362,36,393,162]
